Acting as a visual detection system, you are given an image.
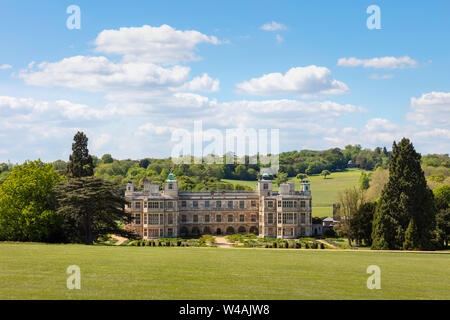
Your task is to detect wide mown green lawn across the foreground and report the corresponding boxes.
[0,243,450,299]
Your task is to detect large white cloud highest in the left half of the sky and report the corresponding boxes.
[94,24,220,63]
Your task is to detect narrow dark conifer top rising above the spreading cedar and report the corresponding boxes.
[67,132,94,178]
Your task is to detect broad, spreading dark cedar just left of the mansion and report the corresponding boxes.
[55,177,133,244]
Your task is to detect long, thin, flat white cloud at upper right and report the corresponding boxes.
[337,56,418,69]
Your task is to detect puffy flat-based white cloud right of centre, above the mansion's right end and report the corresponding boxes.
[237,65,349,96]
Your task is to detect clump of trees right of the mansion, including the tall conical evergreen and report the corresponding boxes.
[336,138,450,250]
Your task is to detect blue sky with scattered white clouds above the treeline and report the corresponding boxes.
[0,0,450,163]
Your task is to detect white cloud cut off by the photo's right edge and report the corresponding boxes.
[406,91,450,128]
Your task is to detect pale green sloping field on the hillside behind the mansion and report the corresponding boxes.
[223,169,361,217]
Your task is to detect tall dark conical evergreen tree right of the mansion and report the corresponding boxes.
[372,138,435,250]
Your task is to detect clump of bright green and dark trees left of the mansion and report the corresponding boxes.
[0,132,135,244]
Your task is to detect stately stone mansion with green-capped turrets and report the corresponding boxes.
[125,174,312,239]
